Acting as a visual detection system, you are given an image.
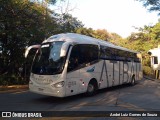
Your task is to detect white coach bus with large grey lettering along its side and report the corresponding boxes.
[25,33,142,97]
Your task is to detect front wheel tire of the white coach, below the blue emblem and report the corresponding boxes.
[86,82,97,96]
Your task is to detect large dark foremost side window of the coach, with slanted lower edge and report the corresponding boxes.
[67,44,99,72]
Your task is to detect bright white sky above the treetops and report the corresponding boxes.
[52,0,160,38]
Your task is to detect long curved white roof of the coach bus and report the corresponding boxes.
[43,33,137,53]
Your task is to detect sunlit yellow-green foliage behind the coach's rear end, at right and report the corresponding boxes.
[110,22,160,76]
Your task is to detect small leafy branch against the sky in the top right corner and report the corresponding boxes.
[137,0,160,15]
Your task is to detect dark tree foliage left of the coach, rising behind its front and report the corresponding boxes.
[0,0,83,84]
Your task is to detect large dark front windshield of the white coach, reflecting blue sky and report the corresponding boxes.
[31,41,65,75]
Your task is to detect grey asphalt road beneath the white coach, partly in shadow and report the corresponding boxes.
[0,79,160,119]
